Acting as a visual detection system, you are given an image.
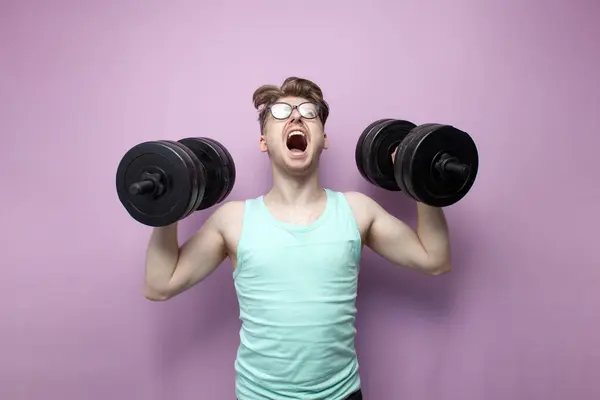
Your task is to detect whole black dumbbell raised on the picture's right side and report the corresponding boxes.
[355,119,479,207]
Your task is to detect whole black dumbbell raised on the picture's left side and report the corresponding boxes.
[116,137,235,227]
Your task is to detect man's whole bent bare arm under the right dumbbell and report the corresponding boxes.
[351,194,451,275]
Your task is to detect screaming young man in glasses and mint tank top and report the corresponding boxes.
[146,77,451,400]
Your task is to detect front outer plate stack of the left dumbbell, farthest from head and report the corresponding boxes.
[116,141,195,227]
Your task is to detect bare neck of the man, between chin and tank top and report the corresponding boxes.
[265,164,324,205]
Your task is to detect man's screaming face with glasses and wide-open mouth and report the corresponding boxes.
[260,97,329,172]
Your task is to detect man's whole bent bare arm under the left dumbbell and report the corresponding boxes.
[144,203,228,301]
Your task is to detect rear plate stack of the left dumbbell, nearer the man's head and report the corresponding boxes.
[179,137,235,210]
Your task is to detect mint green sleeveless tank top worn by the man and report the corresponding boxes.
[233,189,361,400]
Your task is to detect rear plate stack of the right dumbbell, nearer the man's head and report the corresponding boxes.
[363,119,416,191]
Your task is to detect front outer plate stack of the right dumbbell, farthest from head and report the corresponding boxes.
[401,124,479,207]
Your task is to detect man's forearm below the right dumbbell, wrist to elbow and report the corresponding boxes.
[417,203,450,269]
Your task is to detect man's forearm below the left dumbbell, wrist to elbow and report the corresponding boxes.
[146,224,179,293]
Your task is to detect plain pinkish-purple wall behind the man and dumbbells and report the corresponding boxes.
[0,0,600,400]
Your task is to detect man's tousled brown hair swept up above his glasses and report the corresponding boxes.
[252,76,329,133]
